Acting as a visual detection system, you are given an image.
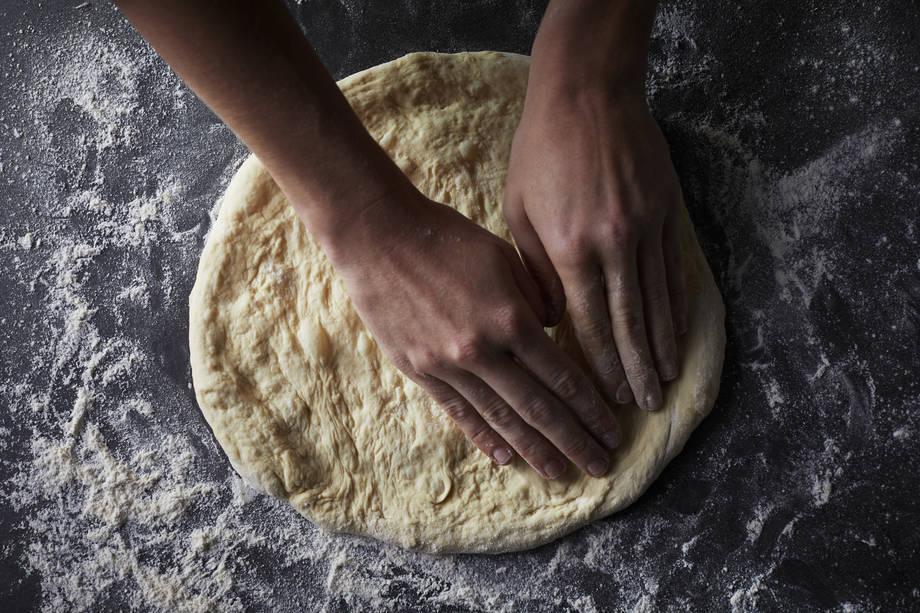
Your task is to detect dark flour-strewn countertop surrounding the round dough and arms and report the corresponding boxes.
[0,0,920,611]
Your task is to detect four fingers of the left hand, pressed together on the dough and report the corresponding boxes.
[410,296,621,479]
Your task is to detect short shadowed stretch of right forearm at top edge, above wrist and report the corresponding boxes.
[531,0,658,93]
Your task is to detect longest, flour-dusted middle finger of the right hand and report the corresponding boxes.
[605,245,661,411]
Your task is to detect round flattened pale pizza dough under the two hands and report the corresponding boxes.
[189,52,725,552]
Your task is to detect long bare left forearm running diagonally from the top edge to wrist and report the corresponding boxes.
[116,0,404,244]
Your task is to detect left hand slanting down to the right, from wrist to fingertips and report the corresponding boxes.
[324,186,620,479]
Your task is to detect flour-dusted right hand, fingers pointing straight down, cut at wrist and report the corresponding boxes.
[504,86,687,410]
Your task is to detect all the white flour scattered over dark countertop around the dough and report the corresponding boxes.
[0,0,920,612]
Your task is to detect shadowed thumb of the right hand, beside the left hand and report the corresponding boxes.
[505,204,565,326]
